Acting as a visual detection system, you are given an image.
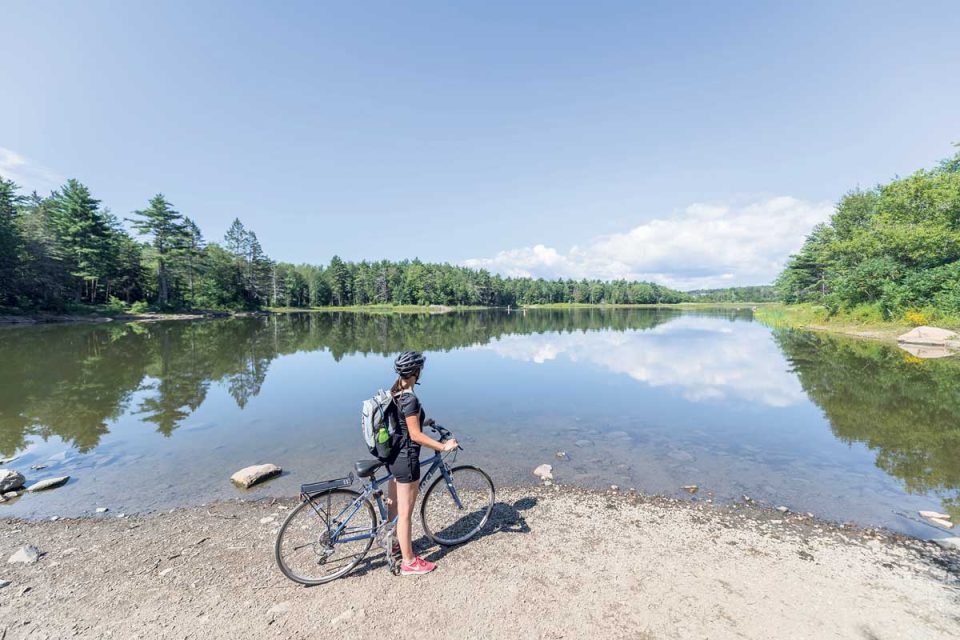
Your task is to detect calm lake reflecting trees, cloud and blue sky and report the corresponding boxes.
[0,309,960,537]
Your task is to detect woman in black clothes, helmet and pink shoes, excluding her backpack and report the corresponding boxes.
[387,351,458,576]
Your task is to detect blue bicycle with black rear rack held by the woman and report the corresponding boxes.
[274,425,495,585]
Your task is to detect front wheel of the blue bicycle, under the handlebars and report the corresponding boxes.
[420,465,495,546]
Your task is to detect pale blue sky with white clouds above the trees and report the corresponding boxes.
[0,0,960,287]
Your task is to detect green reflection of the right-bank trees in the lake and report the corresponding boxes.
[775,331,960,520]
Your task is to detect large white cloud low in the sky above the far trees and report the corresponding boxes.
[465,196,833,289]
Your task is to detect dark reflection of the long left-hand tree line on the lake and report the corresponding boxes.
[0,309,745,456]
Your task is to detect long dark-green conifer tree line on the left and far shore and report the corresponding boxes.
[0,176,687,311]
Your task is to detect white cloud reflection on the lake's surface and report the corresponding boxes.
[474,315,806,407]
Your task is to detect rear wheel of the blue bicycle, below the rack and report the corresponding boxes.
[274,489,377,585]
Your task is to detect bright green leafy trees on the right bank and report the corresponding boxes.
[776,152,960,319]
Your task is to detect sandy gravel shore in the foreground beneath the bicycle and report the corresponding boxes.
[0,488,960,640]
